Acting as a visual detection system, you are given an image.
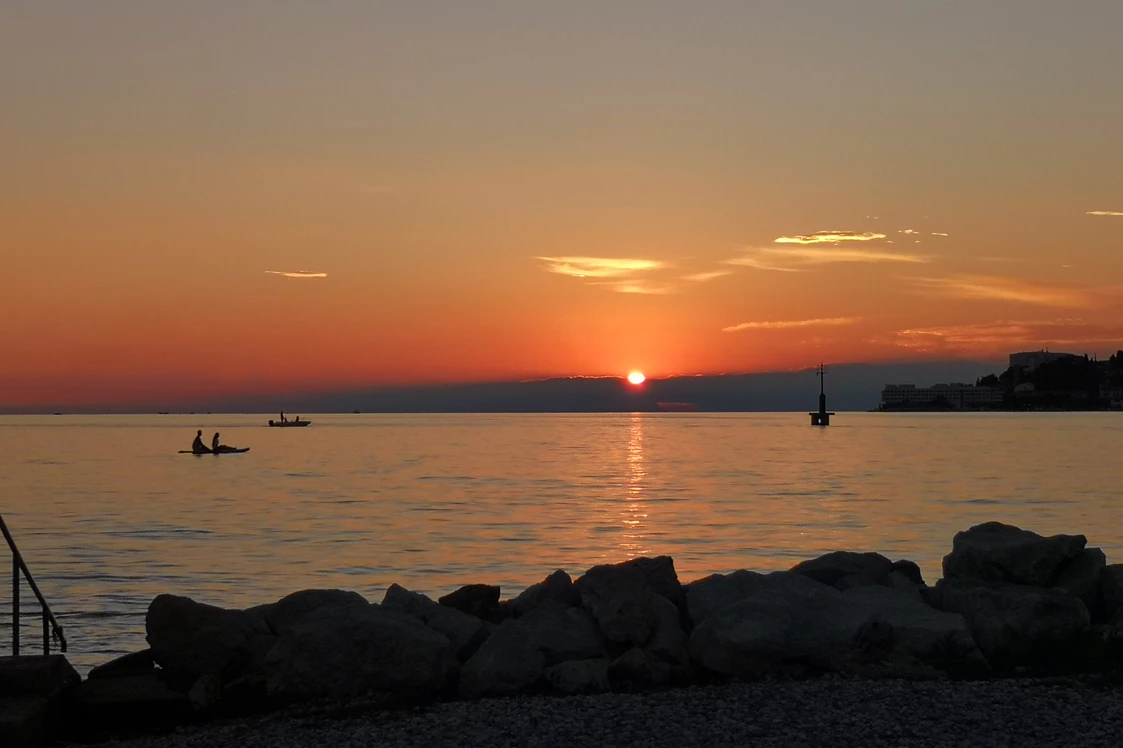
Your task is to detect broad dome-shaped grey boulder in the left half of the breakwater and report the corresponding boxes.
[264,605,459,700]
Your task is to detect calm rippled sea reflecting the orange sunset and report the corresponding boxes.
[0,413,1123,671]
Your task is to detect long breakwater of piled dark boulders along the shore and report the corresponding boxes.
[52,522,1123,731]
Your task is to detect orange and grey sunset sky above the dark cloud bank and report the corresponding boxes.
[0,0,1123,404]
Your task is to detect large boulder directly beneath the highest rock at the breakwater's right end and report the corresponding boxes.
[934,580,1090,669]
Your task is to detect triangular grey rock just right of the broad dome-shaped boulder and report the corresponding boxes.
[459,619,546,699]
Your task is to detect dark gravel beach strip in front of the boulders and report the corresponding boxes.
[83,679,1123,748]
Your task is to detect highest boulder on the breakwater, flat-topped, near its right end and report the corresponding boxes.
[943,522,1087,587]
